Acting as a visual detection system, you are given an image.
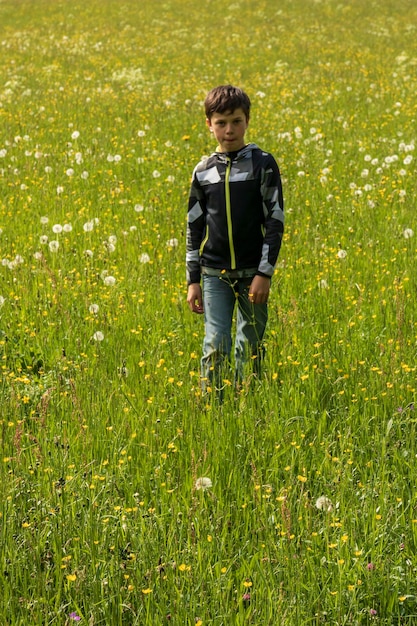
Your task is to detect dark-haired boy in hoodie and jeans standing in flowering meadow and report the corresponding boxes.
[186,85,284,394]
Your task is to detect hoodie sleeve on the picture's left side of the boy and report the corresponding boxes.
[186,167,206,285]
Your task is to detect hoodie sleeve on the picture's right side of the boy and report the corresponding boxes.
[257,153,284,277]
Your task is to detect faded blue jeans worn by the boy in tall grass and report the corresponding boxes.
[201,274,268,390]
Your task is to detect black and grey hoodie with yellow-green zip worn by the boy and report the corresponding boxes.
[187,143,284,284]
